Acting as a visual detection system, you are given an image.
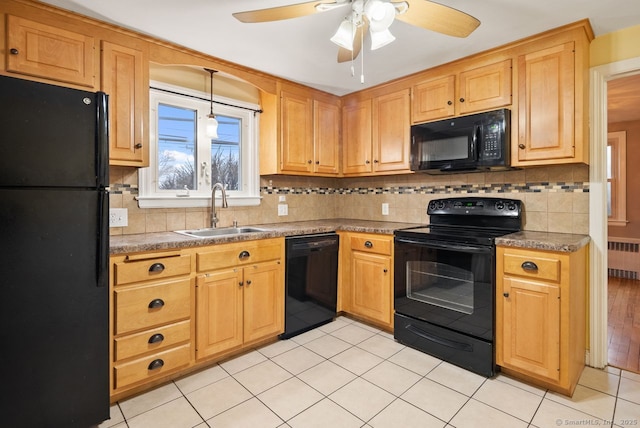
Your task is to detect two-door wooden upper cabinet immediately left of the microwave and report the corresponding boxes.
[342,89,411,175]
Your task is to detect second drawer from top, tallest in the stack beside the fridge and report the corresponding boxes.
[114,278,191,334]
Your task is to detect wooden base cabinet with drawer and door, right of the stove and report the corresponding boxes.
[496,246,588,395]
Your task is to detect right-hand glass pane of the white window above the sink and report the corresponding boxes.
[211,115,242,190]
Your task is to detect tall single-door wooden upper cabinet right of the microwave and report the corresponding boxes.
[511,23,593,166]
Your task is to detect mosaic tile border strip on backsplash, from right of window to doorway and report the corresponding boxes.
[260,182,589,195]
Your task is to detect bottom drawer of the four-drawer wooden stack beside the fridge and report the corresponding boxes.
[113,344,191,389]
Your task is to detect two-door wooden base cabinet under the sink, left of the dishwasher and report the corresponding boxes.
[196,238,284,360]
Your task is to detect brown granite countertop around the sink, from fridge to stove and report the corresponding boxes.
[109,219,420,255]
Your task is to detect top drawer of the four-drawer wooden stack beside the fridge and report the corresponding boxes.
[114,254,191,285]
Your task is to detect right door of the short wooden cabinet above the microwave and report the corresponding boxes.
[458,59,511,114]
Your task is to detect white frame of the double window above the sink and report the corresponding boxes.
[136,81,261,208]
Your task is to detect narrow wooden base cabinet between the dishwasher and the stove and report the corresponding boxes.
[340,232,393,330]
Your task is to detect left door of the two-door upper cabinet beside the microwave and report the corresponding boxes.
[342,100,373,174]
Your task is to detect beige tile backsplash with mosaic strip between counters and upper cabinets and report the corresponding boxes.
[110,165,589,235]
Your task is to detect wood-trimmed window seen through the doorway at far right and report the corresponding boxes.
[607,131,627,226]
